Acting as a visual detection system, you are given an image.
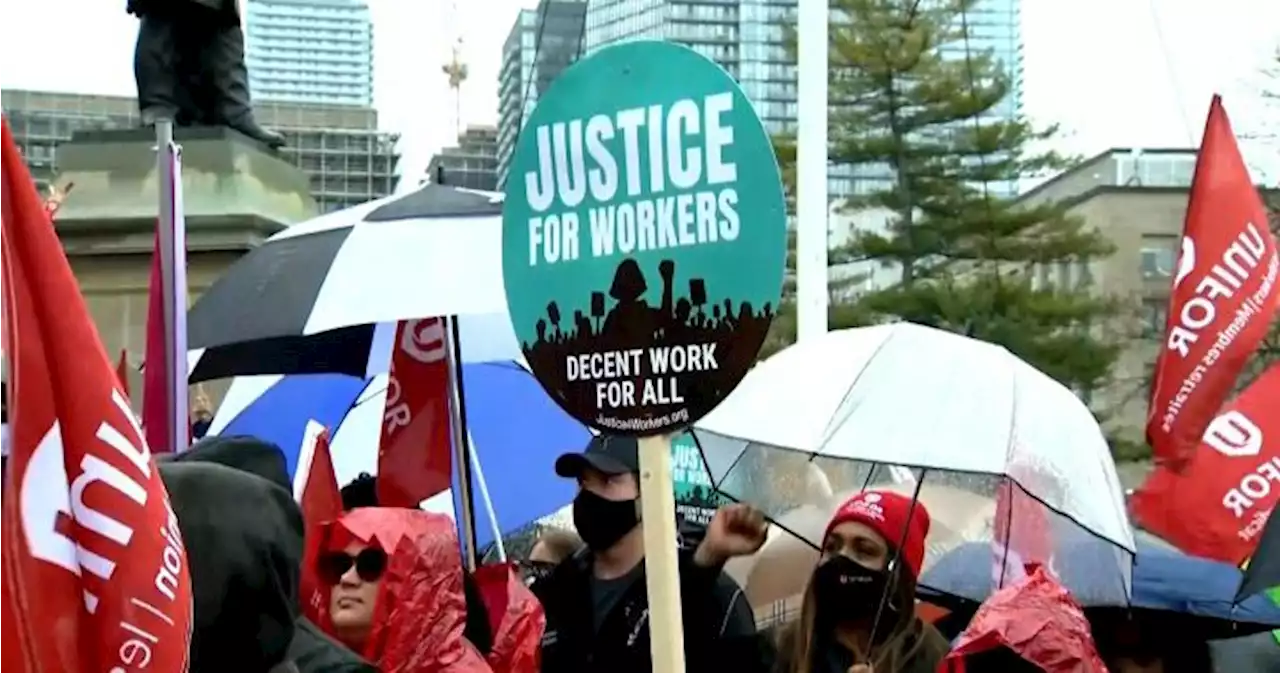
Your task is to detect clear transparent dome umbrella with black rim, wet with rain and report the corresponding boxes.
[694,322,1134,605]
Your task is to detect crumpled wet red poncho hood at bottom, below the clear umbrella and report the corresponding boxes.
[938,567,1107,673]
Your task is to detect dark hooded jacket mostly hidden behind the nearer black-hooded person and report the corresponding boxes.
[163,436,378,673]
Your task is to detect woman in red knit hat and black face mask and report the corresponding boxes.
[774,490,947,673]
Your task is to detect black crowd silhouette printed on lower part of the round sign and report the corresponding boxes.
[521,257,773,420]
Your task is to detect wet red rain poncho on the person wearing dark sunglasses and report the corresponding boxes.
[316,507,492,673]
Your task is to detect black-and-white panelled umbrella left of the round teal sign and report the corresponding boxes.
[187,184,507,383]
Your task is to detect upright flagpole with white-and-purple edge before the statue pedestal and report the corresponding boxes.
[156,120,189,453]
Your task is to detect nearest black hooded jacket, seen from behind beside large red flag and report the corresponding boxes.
[160,463,302,673]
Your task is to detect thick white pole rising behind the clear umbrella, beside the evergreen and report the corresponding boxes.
[796,0,829,340]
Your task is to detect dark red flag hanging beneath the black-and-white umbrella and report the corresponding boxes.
[378,317,452,508]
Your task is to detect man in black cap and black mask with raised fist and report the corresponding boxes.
[531,435,771,673]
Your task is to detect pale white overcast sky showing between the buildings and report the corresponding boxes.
[0,0,1280,184]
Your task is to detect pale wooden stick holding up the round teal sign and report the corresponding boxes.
[639,435,685,673]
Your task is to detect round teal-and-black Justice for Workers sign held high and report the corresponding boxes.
[502,41,786,435]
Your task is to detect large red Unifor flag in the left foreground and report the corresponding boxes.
[0,119,192,673]
